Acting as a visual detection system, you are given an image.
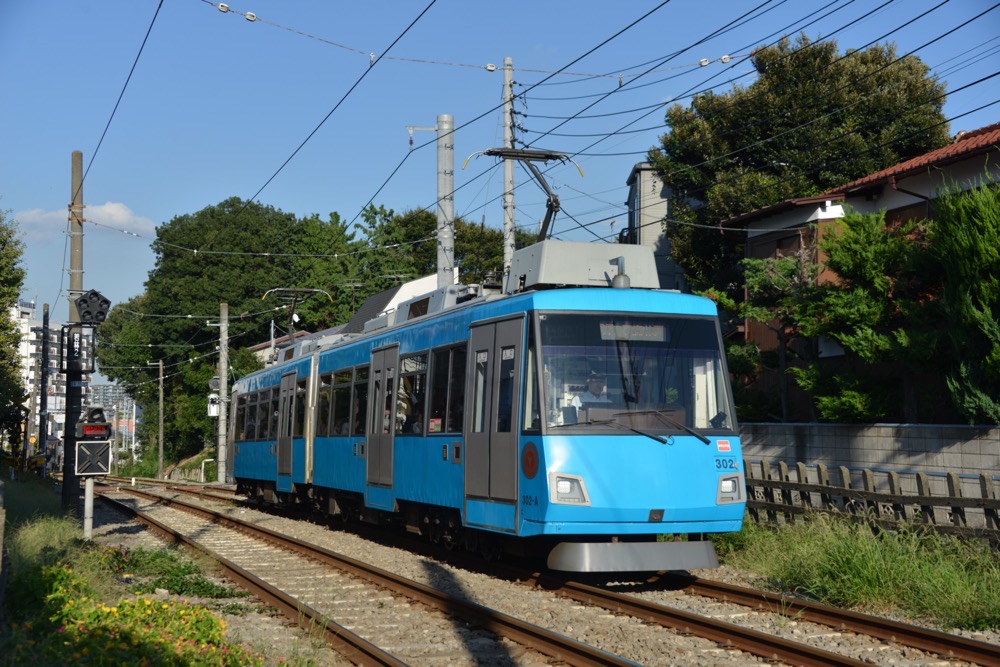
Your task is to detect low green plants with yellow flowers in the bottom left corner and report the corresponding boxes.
[0,494,264,666]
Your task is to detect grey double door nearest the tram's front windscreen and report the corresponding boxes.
[465,318,524,502]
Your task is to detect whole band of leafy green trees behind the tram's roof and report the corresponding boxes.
[97,198,525,460]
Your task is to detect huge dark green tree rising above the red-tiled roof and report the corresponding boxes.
[649,36,948,298]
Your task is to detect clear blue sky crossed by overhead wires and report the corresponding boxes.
[0,0,1000,321]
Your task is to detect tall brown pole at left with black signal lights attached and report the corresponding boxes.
[62,151,84,513]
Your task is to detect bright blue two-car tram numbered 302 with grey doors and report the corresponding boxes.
[230,241,746,571]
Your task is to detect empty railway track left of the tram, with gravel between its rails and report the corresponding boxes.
[101,488,635,665]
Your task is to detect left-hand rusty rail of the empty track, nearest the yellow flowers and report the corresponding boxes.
[100,489,406,667]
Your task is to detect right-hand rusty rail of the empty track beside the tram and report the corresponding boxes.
[101,488,640,667]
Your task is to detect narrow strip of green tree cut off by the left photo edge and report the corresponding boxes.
[0,211,25,442]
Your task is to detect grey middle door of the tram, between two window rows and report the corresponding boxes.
[367,346,399,487]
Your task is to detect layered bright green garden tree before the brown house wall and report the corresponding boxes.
[794,212,938,422]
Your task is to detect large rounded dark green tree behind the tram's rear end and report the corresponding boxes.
[96,198,312,461]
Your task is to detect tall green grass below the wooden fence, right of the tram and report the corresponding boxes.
[714,515,1000,630]
